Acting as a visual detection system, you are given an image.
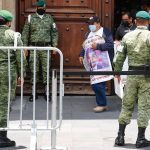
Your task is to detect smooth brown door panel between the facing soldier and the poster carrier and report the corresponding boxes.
[57,21,87,67]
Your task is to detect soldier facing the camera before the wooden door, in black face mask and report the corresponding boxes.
[22,0,58,101]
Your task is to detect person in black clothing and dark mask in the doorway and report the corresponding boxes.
[115,12,136,41]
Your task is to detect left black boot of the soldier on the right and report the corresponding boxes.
[115,124,126,146]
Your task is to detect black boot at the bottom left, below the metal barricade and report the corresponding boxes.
[0,131,16,148]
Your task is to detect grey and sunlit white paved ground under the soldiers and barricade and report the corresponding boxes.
[3,96,150,150]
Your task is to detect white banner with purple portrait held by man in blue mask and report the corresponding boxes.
[83,29,113,84]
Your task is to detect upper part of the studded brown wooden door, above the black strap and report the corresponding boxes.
[18,0,113,95]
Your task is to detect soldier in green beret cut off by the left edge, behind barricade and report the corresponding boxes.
[0,10,23,148]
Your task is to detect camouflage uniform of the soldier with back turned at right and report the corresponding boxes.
[114,26,150,127]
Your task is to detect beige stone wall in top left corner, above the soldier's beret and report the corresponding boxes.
[0,0,16,29]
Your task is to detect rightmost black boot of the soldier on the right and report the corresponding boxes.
[136,127,150,148]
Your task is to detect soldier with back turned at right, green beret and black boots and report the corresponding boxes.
[114,11,150,148]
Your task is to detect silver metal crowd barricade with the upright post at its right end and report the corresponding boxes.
[0,47,67,150]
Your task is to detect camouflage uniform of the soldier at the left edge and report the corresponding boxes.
[0,25,22,127]
